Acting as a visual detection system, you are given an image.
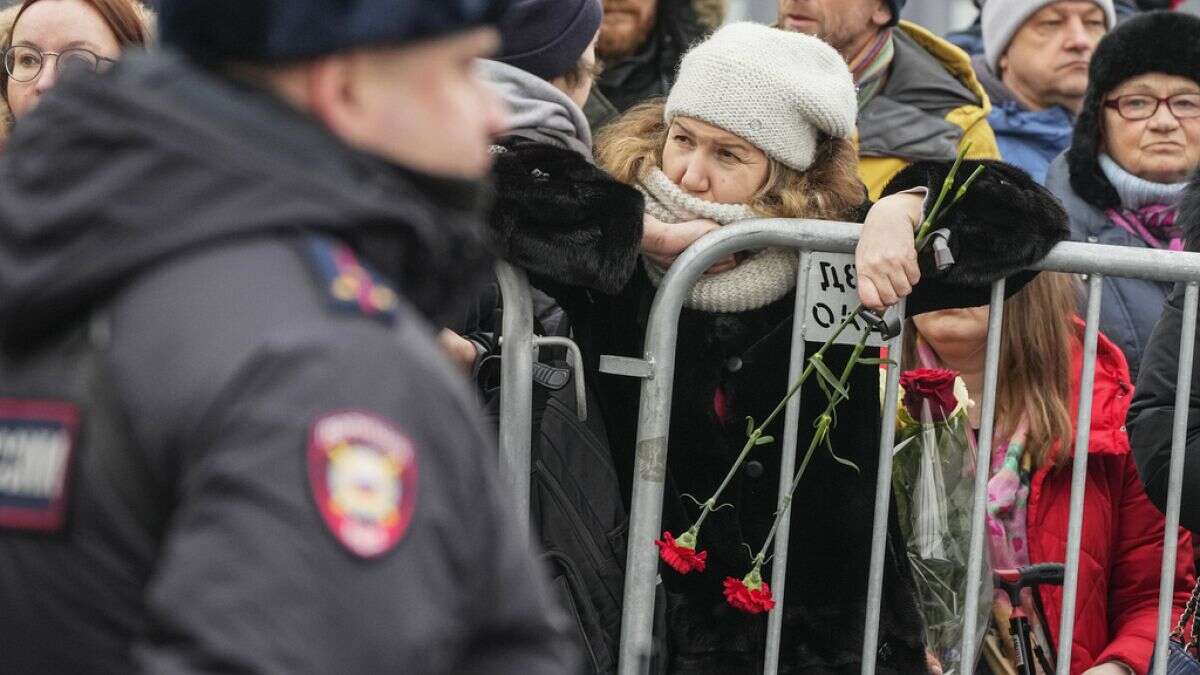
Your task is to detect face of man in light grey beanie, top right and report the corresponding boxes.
[1000,0,1108,110]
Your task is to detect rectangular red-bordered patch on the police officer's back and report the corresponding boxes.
[0,399,79,532]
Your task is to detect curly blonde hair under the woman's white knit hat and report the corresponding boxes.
[596,98,866,220]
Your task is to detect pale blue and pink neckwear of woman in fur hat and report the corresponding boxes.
[1099,155,1187,251]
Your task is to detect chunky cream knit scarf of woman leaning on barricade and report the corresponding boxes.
[637,167,799,313]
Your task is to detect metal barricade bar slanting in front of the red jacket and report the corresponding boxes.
[1057,274,1104,675]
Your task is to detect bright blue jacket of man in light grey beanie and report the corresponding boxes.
[972,56,1075,184]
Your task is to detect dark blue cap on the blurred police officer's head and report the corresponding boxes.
[158,0,509,62]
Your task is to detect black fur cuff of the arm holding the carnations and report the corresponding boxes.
[883,160,1070,316]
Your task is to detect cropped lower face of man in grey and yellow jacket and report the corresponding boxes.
[779,0,892,60]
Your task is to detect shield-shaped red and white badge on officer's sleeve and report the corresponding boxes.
[308,411,416,558]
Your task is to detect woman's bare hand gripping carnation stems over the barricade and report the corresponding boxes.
[854,186,925,310]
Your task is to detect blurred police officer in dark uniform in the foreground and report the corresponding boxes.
[0,0,574,675]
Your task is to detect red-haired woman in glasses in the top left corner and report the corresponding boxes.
[0,0,151,126]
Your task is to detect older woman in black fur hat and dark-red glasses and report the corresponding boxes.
[1046,12,1200,377]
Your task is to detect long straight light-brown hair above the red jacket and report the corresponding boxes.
[902,271,1081,467]
